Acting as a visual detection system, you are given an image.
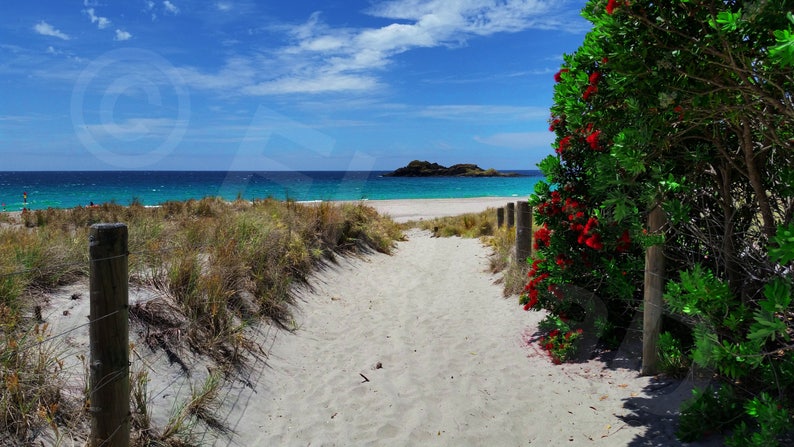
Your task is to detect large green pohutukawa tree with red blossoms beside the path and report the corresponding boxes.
[522,0,794,445]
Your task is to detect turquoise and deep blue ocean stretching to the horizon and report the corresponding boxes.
[0,171,543,211]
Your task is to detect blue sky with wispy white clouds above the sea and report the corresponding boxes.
[0,0,588,171]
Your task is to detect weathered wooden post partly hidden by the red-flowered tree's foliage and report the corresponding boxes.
[641,208,667,376]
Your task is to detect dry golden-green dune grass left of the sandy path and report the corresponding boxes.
[0,198,402,445]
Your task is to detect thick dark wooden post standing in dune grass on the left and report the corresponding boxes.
[88,223,130,447]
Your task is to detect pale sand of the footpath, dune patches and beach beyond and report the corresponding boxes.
[38,198,717,446]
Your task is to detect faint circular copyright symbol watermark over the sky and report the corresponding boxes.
[71,48,190,169]
